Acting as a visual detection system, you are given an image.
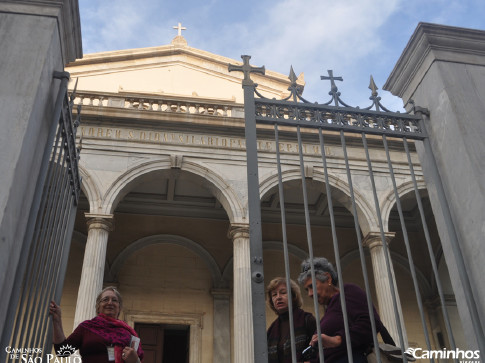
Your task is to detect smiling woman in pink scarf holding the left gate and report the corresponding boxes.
[49,286,143,363]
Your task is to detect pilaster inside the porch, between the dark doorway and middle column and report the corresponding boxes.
[211,289,231,363]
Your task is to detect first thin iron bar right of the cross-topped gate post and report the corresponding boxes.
[274,124,297,363]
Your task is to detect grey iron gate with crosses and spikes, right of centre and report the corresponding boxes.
[229,56,484,363]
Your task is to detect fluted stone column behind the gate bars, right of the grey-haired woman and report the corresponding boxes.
[362,232,408,347]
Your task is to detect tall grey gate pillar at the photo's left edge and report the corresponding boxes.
[0,0,82,341]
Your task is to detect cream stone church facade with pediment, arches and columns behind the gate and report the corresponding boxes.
[56,35,462,363]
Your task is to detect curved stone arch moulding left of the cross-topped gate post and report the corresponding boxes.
[101,157,246,223]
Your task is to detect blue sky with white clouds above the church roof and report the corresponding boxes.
[79,0,485,110]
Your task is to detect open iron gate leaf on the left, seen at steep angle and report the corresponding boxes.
[0,72,81,362]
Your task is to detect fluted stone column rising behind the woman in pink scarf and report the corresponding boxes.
[74,213,113,328]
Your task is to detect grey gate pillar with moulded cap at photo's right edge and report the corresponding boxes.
[384,23,485,352]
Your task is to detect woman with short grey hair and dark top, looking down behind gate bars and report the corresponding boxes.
[298,257,383,363]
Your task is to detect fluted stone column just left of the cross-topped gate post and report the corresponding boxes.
[229,224,254,363]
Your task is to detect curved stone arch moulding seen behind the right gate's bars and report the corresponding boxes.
[260,168,379,236]
